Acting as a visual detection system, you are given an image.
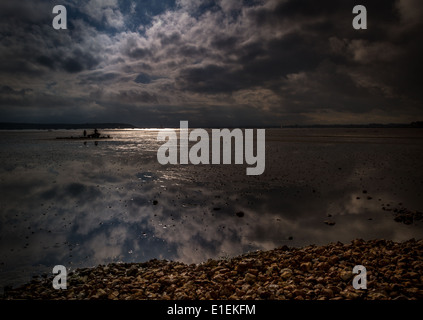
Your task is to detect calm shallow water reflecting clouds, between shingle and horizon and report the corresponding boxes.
[0,129,423,287]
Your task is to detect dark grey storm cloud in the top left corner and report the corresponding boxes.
[0,1,103,77]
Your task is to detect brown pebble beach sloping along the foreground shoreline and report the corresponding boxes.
[2,239,423,300]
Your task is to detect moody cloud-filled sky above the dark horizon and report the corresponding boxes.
[0,0,423,127]
